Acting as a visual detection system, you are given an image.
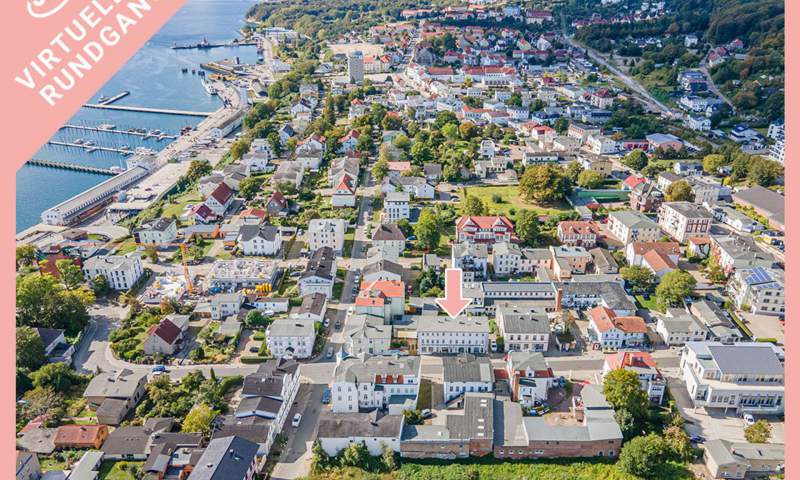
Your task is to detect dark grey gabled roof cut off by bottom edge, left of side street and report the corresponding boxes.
[189,436,258,480]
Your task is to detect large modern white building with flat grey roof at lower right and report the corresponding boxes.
[680,342,785,414]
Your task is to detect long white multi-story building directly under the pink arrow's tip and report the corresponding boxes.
[416,315,490,354]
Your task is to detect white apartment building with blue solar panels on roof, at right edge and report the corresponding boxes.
[727,267,786,317]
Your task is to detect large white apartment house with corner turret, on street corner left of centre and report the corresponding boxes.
[331,356,420,413]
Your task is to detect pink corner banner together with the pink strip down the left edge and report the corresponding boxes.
[0,0,186,464]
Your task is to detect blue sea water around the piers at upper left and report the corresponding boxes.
[16,0,257,231]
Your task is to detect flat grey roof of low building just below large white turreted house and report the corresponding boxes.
[317,409,403,438]
